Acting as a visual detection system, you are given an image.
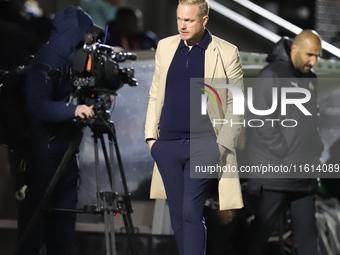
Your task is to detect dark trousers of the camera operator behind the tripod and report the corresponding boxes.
[18,155,78,255]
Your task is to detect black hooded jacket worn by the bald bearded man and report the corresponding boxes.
[246,37,323,191]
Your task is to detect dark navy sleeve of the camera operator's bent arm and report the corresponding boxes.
[25,70,77,122]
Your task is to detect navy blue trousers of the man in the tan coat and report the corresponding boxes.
[151,136,220,255]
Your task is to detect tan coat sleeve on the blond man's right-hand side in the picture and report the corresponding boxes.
[217,47,244,151]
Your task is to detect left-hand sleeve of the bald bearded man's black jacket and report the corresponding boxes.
[253,69,288,158]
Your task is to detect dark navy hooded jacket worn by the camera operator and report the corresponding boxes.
[25,6,93,156]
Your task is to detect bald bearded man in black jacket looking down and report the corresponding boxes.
[247,30,323,255]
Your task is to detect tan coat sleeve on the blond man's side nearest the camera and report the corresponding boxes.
[145,42,161,140]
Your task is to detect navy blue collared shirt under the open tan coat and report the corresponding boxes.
[159,29,214,140]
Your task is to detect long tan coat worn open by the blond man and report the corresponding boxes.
[145,32,243,210]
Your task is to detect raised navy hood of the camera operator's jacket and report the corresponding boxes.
[33,6,93,72]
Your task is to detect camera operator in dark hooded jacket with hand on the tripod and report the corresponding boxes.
[18,6,99,255]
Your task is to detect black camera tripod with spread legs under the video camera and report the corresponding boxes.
[17,118,138,255]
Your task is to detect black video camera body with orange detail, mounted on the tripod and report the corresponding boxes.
[72,43,138,119]
